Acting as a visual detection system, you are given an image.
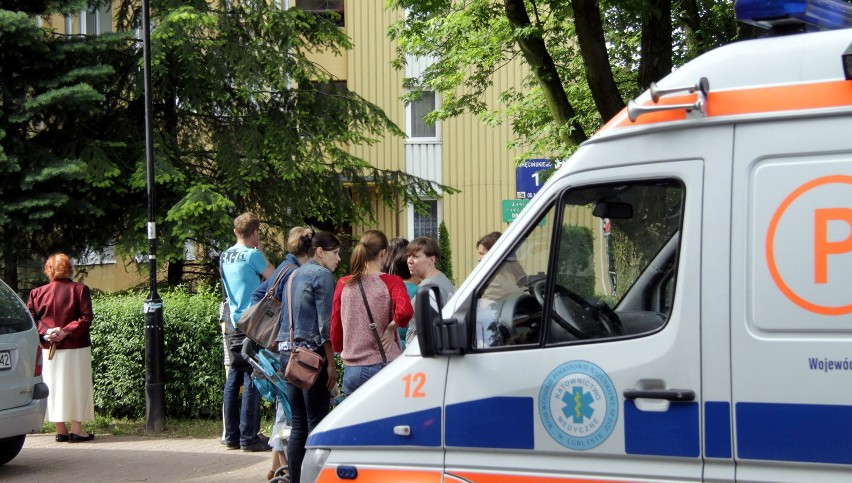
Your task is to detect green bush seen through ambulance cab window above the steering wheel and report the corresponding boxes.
[556,225,595,299]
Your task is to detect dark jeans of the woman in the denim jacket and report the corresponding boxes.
[279,353,331,483]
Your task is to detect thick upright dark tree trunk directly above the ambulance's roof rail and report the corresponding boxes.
[638,0,672,91]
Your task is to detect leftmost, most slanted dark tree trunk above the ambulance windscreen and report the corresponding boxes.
[504,0,588,145]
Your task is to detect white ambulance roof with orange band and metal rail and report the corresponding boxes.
[593,29,852,135]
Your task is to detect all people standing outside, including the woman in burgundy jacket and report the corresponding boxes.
[21,213,480,482]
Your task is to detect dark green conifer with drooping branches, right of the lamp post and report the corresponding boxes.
[112,0,454,280]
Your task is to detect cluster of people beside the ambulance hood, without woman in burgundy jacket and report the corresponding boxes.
[221,213,455,482]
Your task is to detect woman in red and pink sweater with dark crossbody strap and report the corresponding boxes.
[331,230,414,396]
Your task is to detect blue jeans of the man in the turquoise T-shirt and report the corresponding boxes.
[224,369,260,446]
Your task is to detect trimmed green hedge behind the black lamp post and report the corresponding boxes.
[91,287,225,419]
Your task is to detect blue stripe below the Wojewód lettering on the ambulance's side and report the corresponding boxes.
[736,402,852,465]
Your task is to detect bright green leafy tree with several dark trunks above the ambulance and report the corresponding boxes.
[389,0,754,163]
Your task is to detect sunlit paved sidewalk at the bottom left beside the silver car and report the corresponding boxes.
[0,434,272,482]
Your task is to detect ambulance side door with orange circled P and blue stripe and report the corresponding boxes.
[730,116,852,482]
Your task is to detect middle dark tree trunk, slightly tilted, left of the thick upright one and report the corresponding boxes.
[571,0,624,121]
